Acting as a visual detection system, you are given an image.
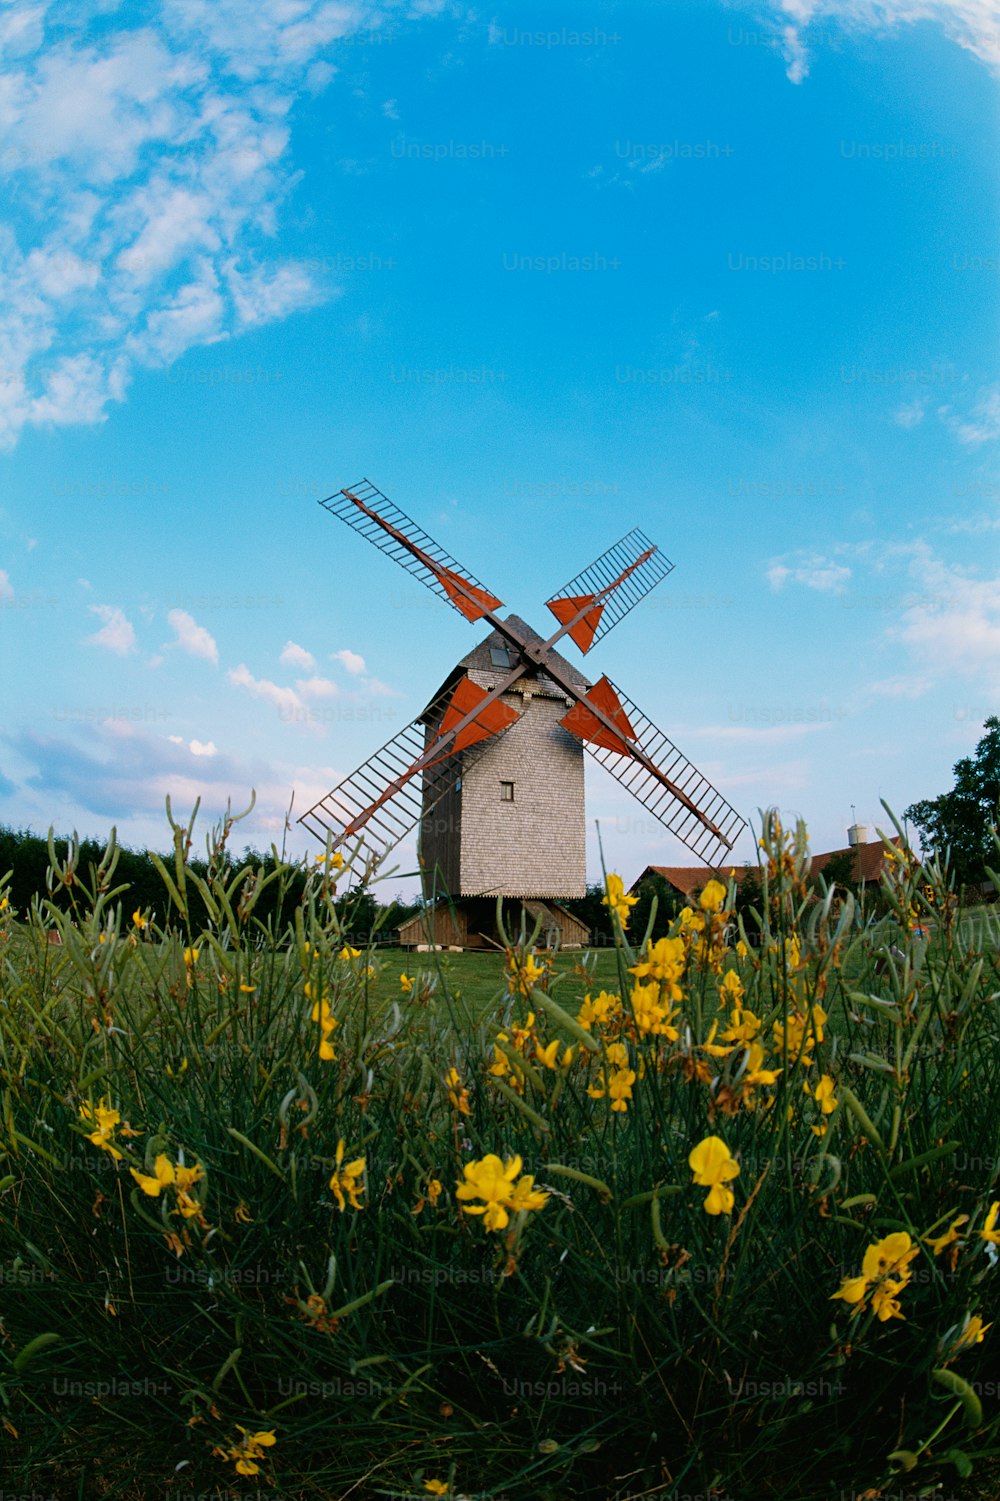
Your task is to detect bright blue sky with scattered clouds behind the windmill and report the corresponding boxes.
[0,0,1000,889]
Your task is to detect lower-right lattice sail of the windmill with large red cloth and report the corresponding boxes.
[560,677,746,866]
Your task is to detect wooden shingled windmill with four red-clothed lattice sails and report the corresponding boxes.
[299,480,745,943]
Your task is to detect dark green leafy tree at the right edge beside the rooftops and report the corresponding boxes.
[904,714,1000,884]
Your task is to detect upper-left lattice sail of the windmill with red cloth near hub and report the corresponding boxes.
[320,479,503,620]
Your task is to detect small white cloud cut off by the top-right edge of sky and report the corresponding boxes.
[767,0,1000,84]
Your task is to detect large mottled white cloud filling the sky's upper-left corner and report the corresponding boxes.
[0,0,408,447]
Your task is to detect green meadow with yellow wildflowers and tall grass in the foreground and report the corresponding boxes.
[0,814,1000,1501]
